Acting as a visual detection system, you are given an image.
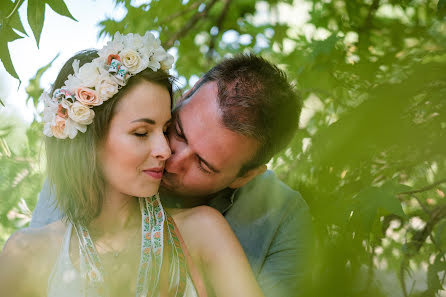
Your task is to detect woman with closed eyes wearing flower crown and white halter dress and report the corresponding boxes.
[0,33,262,297]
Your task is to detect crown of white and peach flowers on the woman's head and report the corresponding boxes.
[40,32,174,139]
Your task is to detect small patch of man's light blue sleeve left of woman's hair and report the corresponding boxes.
[29,179,61,228]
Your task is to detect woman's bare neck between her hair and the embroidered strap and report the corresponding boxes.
[89,189,141,235]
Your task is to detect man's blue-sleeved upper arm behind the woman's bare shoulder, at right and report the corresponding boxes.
[257,201,313,297]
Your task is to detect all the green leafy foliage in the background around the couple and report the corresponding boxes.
[0,0,446,296]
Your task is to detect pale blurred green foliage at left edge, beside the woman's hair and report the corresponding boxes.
[0,56,57,247]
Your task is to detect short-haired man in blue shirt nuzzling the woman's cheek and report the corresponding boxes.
[31,55,311,297]
